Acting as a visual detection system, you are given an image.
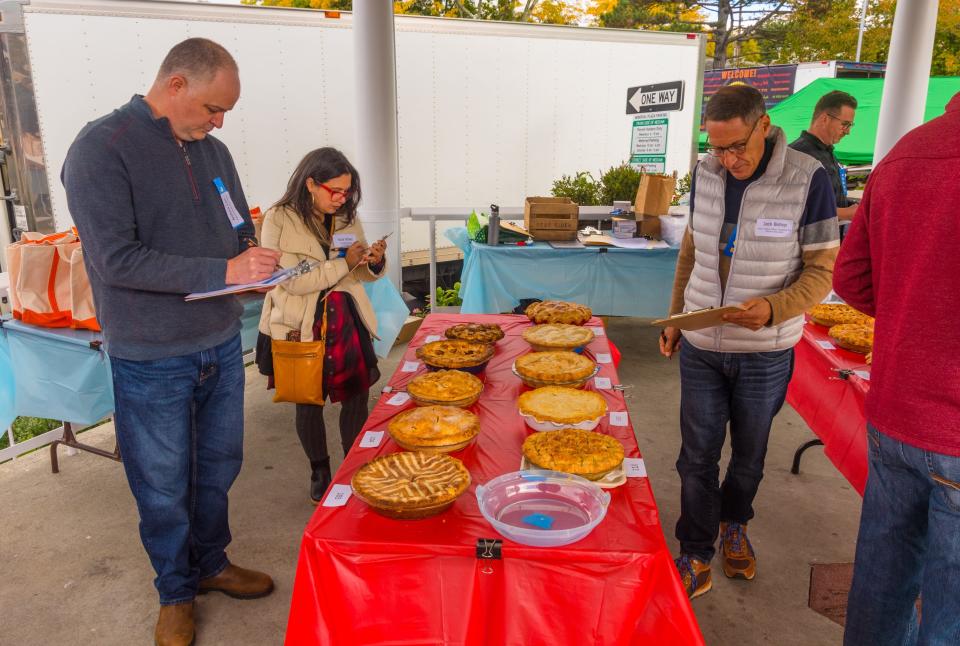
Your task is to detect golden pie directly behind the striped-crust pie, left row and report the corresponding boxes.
[387,406,480,453]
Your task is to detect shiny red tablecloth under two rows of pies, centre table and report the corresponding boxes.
[286,314,703,646]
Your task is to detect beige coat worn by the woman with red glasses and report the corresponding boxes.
[260,207,386,341]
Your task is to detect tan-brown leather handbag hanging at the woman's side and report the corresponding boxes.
[271,303,327,406]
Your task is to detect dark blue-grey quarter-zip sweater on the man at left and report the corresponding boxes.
[61,95,254,361]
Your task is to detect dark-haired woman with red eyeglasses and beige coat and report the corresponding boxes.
[256,148,387,504]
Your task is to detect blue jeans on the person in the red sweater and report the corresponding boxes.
[843,424,960,646]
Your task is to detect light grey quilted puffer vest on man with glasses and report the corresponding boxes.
[683,127,821,352]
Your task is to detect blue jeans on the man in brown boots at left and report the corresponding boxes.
[110,334,244,605]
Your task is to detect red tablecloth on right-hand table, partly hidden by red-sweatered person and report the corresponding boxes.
[787,321,870,496]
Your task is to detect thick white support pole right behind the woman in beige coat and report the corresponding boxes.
[353,0,401,289]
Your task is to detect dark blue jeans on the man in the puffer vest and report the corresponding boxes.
[676,341,793,563]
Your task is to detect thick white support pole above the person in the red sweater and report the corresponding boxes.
[873,0,939,166]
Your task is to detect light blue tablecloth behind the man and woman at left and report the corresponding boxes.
[0,280,409,433]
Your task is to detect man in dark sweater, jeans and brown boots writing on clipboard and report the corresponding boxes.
[61,38,279,646]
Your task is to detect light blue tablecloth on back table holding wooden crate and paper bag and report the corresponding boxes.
[446,227,677,318]
